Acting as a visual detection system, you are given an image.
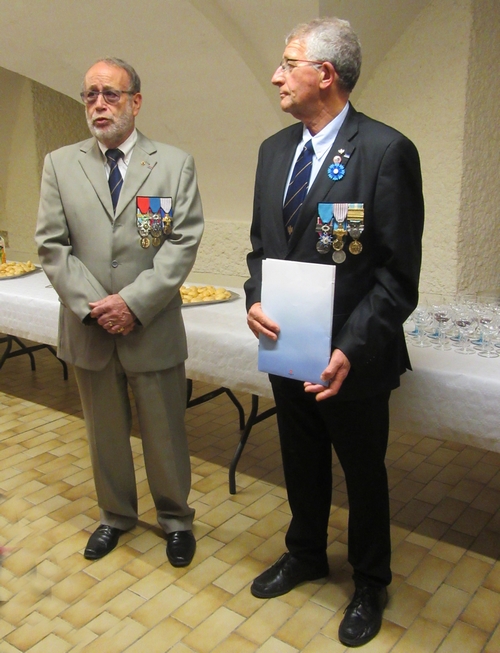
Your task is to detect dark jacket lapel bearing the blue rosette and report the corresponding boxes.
[288,106,358,251]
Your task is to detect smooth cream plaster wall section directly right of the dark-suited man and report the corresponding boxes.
[357,0,472,295]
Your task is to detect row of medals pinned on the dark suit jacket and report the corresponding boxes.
[316,204,364,263]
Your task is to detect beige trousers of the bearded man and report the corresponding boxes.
[75,354,194,533]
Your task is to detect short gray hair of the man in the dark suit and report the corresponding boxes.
[285,17,361,92]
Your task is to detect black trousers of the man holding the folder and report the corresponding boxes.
[270,375,391,586]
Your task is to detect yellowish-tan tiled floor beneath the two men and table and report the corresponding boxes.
[0,344,500,653]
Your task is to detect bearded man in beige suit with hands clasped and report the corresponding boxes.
[36,59,203,567]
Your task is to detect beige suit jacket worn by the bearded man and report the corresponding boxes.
[35,132,203,372]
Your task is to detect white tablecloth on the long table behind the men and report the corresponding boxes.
[0,271,500,451]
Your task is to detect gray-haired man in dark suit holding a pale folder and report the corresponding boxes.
[245,18,424,646]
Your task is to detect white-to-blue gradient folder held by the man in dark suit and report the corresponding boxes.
[258,259,336,385]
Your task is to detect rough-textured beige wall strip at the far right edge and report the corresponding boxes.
[457,0,500,295]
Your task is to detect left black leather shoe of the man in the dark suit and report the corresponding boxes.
[250,553,329,599]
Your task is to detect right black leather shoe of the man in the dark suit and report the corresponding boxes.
[339,585,388,646]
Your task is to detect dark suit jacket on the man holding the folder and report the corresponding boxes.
[245,106,424,400]
